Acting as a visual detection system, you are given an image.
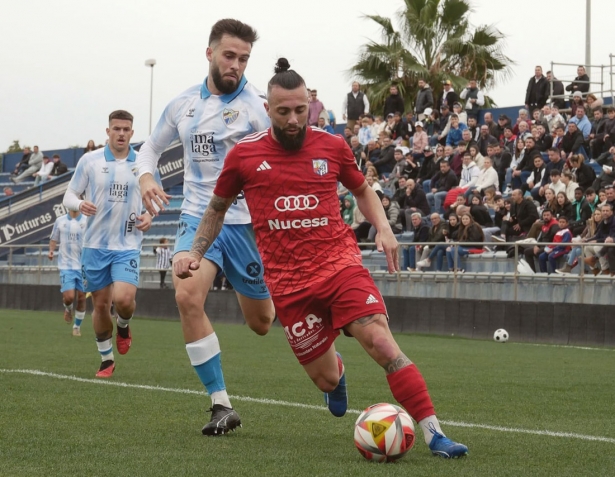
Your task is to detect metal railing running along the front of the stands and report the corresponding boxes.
[0,240,615,303]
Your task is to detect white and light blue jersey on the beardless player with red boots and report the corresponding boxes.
[68,146,143,250]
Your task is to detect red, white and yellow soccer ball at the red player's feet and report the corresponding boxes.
[354,403,414,462]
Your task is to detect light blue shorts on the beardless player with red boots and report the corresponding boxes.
[81,248,141,292]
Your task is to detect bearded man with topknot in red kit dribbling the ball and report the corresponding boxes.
[174,58,468,458]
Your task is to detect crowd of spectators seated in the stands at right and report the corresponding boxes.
[340,66,615,275]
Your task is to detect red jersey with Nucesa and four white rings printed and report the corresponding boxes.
[214,127,365,296]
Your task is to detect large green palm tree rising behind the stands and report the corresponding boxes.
[348,0,514,115]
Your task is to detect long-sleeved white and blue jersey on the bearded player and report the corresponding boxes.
[137,76,270,224]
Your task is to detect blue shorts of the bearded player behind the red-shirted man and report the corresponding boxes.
[175,214,269,300]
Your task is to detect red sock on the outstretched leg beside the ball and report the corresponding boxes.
[387,364,436,422]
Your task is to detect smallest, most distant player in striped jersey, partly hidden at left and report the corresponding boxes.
[47,210,86,336]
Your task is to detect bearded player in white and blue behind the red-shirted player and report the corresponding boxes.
[138,19,276,436]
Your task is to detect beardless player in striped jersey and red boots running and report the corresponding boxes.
[64,110,152,378]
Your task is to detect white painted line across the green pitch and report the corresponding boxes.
[0,369,615,444]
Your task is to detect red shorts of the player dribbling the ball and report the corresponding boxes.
[272,267,387,364]
